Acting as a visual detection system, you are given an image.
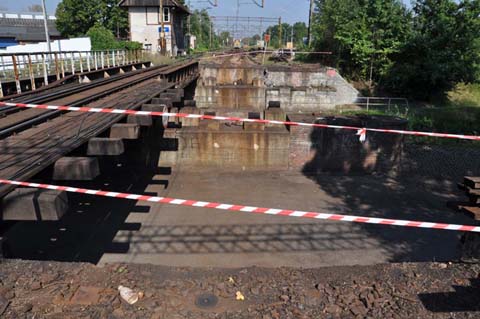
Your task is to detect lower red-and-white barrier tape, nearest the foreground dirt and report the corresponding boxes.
[0,179,480,233]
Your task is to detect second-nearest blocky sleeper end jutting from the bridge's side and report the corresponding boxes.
[53,157,100,181]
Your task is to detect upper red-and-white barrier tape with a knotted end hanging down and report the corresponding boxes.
[0,102,480,141]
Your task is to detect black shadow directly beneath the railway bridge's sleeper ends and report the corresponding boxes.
[2,121,171,263]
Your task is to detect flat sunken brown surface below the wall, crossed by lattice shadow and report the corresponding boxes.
[100,171,469,268]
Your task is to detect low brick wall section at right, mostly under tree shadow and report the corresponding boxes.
[289,115,407,174]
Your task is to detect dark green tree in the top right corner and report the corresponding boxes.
[386,0,480,99]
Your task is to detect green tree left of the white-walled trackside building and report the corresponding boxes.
[56,0,128,37]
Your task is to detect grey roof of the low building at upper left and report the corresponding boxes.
[0,17,61,42]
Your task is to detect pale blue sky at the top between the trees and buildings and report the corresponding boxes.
[0,0,310,23]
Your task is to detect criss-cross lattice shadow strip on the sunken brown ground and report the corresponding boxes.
[107,224,375,254]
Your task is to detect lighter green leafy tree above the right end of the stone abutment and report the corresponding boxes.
[313,0,411,80]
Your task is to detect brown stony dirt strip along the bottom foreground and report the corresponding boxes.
[0,260,480,319]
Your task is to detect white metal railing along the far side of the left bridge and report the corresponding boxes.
[0,50,144,97]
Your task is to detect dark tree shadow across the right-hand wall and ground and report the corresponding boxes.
[303,129,474,262]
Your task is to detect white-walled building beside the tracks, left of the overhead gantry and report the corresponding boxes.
[119,0,190,56]
